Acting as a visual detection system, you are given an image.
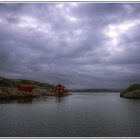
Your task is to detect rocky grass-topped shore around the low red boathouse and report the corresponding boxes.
[0,77,55,97]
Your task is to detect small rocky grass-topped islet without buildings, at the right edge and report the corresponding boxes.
[120,84,140,99]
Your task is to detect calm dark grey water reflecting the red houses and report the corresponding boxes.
[0,93,140,137]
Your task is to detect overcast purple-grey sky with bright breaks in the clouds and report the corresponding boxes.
[0,2,140,89]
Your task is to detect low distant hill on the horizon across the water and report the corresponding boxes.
[71,89,119,92]
